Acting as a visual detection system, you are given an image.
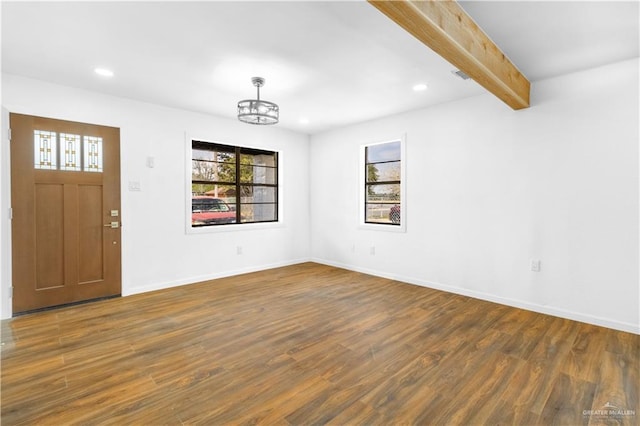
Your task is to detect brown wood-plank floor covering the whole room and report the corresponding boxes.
[1,263,640,426]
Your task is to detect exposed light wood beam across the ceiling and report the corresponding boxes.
[367,0,530,110]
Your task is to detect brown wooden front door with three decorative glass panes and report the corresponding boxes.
[10,114,121,313]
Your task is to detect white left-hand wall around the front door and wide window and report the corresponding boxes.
[0,75,310,318]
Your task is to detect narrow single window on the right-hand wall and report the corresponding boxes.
[363,141,402,226]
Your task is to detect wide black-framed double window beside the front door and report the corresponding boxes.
[191,140,278,227]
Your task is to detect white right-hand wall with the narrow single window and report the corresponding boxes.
[310,59,640,333]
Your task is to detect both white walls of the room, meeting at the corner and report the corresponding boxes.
[0,60,640,333]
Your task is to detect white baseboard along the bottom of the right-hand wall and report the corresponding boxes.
[310,258,640,335]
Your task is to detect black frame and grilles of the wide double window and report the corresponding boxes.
[191,139,280,228]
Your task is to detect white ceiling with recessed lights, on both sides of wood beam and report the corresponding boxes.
[2,1,639,133]
